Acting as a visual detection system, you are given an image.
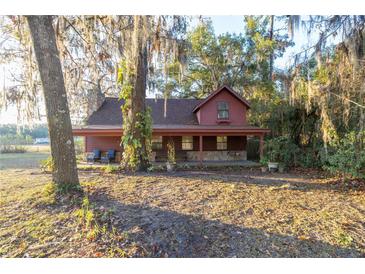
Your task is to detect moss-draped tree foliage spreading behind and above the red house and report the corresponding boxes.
[0,15,365,178]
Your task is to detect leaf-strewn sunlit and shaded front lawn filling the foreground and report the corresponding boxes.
[0,169,365,257]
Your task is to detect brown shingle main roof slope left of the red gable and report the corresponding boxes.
[86,97,203,125]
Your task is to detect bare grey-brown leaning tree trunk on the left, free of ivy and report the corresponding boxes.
[27,16,79,189]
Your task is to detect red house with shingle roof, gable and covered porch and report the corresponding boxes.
[73,86,269,161]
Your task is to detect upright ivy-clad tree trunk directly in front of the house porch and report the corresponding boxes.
[123,16,150,171]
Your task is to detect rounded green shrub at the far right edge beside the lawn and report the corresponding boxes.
[324,131,365,180]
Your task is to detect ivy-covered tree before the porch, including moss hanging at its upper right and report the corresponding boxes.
[119,15,186,171]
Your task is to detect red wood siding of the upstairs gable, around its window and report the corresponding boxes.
[197,90,247,125]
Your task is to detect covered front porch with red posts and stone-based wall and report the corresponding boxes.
[73,125,269,165]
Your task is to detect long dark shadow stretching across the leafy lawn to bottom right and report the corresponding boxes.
[90,191,364,257]
